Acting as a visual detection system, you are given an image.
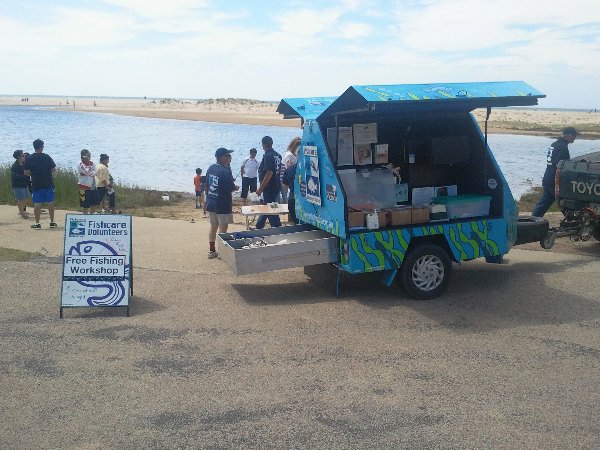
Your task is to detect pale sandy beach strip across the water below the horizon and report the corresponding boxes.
[0,96,600,139]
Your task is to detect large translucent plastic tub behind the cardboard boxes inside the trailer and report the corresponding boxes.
[339,168,396,210]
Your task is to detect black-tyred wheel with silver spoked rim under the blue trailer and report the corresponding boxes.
[398,244,452,300]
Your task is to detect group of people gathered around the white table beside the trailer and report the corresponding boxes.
[204,136,301,259]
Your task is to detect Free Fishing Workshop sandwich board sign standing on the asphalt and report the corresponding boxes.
[60,214,133,318]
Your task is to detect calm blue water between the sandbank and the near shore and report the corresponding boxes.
[0,107,600,198]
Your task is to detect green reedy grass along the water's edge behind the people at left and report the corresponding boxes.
[0,164,189,217]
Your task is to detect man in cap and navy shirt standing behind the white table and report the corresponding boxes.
[256,136,281,230]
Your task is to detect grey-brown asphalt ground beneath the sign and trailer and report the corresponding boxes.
[0,206,600,449]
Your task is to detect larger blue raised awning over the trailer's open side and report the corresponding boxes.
[319,81,545,119]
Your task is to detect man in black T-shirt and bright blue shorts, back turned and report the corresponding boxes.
[24,139,57,230]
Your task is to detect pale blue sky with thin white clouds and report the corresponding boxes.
[0,0,600,109]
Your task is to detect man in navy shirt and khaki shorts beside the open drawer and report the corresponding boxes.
[206,147,239,259]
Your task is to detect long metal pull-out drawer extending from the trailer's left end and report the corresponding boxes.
[217,225,339,275]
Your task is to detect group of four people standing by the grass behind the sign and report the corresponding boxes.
[11,139,115,229]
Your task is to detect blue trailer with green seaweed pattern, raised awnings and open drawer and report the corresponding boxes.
[219,81,545,299]
